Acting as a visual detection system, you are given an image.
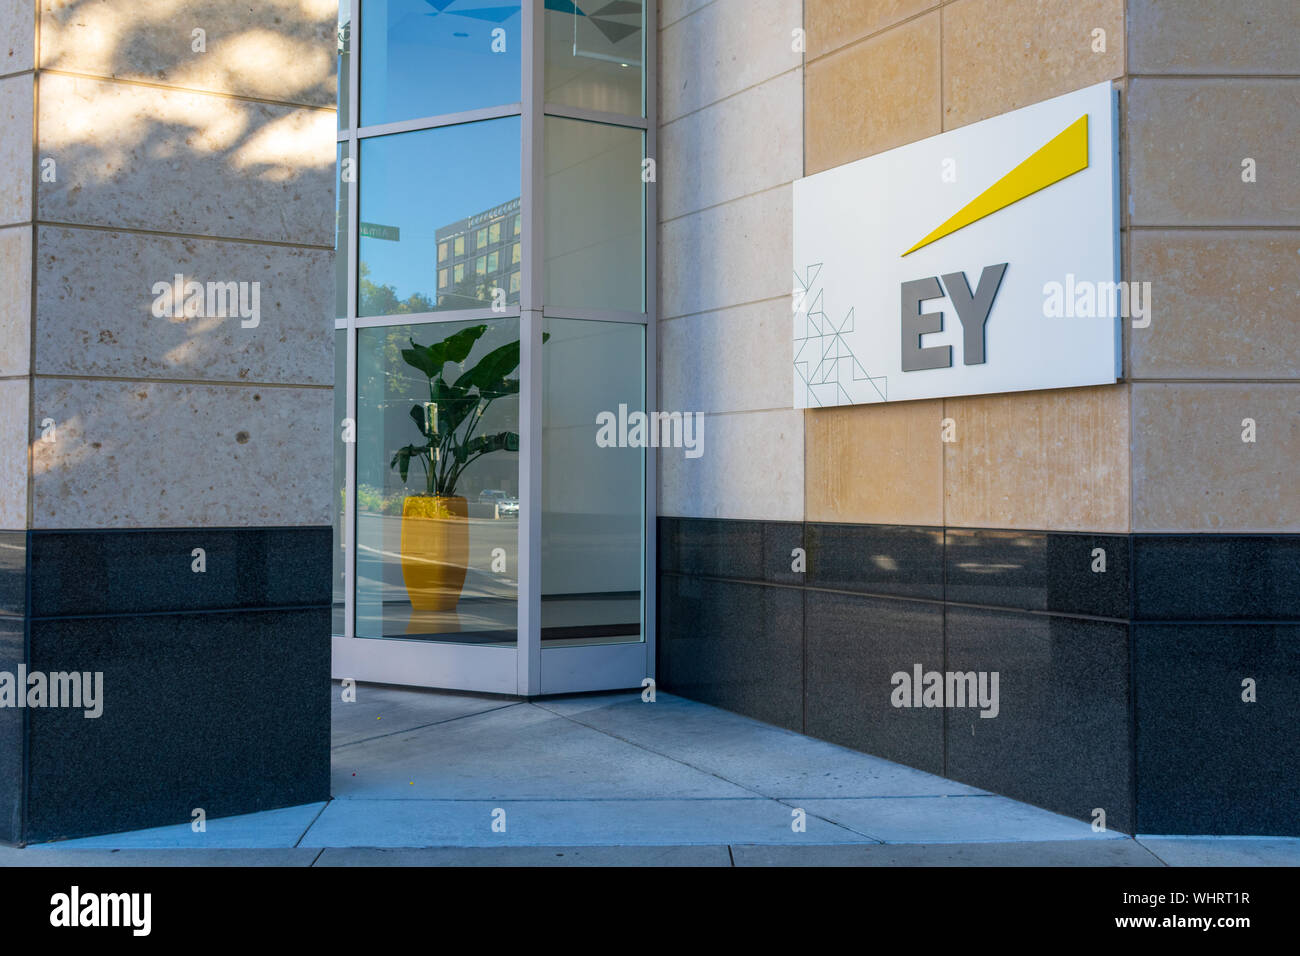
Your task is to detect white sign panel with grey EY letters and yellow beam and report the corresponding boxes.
[793,83,1131,408]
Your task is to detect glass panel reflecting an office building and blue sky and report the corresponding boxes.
[358,119,520,316]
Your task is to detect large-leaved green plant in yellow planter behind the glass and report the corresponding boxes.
[390,325,519,611]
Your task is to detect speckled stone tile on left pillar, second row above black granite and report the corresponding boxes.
[36,226,334,385]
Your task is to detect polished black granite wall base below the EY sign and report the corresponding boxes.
[658,518,1300,835]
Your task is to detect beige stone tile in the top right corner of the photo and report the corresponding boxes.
[1128,0,1300,75]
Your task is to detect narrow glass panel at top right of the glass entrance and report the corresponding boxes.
[546,0,645,116]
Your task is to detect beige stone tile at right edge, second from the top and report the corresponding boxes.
[1127,79,1300,226]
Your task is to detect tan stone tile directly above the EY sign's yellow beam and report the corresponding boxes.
[943,0,1125,130]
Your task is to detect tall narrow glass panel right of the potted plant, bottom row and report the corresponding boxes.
[542,319,647,646]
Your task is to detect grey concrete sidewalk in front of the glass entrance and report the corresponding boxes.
[0,685,1300,866]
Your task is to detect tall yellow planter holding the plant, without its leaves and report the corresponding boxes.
[402,496,469,611]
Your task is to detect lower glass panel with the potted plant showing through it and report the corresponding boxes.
[356,319,519,645]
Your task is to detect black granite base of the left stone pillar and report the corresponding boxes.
[0,527,332,843]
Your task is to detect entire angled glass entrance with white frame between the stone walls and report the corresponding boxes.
[334,0,654,695]
